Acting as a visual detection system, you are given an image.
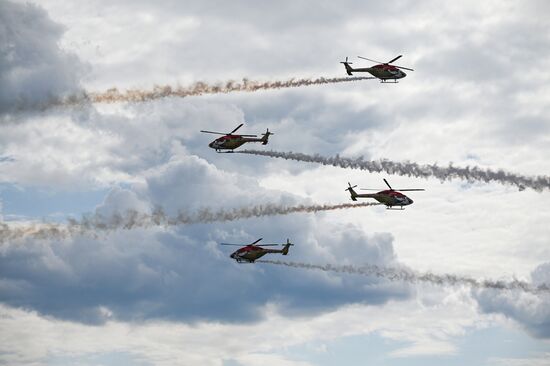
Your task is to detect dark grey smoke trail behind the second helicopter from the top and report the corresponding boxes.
[236,150,550,192]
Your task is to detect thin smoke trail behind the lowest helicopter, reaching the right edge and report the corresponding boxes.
[256,260,550,293]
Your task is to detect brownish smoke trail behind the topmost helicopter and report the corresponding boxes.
[54,76,374,106]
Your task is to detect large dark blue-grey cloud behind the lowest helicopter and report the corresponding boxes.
[0,219,410,323]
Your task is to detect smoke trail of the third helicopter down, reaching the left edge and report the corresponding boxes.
[0,203,379,243]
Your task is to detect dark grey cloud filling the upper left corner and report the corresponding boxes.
[0,0,86,118]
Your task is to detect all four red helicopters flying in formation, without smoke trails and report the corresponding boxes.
[206,55,424,263]
